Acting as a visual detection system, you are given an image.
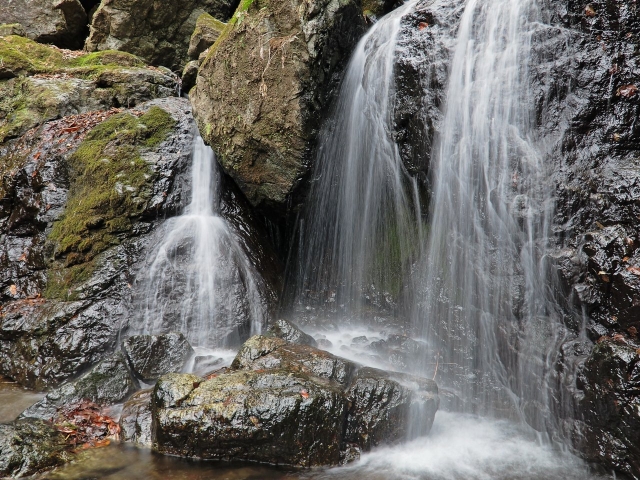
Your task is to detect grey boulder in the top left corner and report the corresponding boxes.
[0,0,87,48]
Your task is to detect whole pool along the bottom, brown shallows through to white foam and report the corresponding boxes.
[35,412,611,480]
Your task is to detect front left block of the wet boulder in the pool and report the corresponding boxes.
[153,370,347,467]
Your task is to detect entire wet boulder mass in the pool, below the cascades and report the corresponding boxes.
[151,336,439,467]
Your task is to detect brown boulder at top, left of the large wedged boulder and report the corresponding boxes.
[85,0,238,71]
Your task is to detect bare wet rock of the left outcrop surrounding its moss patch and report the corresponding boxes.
[0,98,193,389]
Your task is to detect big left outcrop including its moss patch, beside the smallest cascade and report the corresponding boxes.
[0,98,193,389]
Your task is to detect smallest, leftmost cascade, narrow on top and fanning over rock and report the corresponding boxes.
[132,136,266,348]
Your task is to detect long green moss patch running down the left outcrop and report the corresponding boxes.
[45,107,175,299]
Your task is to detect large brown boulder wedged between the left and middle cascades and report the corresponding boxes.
[190,0,364,213]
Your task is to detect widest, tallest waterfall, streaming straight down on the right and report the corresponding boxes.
[414,0,564,429]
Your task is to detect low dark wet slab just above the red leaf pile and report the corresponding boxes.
[20,353,138,420]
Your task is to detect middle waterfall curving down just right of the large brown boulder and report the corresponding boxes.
[292,2,422,318]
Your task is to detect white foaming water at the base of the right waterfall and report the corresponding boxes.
[303,412,604,480]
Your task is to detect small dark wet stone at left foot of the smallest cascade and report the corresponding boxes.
[122,332,195,383]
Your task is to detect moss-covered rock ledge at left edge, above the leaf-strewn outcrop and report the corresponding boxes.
[0,35,176,143]
